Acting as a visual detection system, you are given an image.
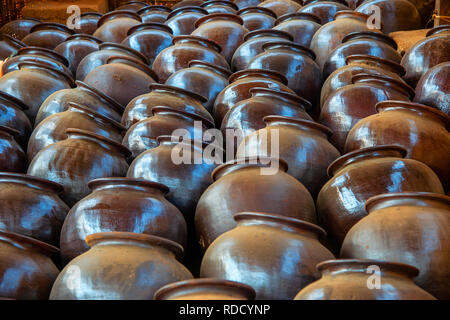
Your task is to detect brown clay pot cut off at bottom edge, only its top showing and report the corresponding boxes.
[154,278,256,300]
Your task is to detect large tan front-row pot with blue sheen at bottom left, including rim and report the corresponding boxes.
[50,232,192,300]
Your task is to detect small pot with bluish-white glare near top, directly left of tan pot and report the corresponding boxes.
[274,12,321,47]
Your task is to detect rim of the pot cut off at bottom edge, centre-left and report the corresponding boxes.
[154,278,256,300]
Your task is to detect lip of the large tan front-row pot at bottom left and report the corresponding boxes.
[86,231,184,260]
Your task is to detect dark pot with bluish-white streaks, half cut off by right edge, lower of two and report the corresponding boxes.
[414,61,450,116]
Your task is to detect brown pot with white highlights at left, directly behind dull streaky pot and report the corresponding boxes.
[27,102,125,162]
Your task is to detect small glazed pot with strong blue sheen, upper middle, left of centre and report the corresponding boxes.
[166,60,231,112]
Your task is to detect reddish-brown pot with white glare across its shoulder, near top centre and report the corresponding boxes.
[192,13,249,63]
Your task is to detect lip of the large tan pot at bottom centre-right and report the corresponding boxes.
[234,211,327,238]
